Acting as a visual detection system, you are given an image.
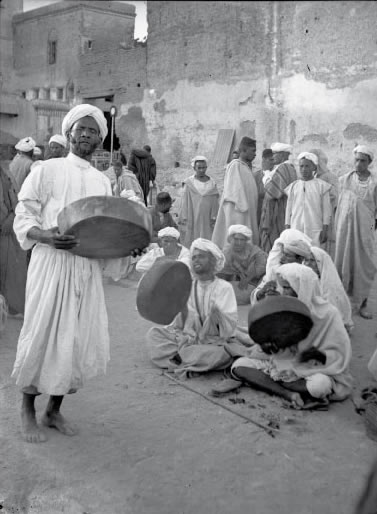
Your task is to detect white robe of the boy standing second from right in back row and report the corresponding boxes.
[284,178,331,246]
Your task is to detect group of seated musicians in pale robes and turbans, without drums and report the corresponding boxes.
[146,225,352,409]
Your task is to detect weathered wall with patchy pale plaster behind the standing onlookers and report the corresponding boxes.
[114,1,377,174]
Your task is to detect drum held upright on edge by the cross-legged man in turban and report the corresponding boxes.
[136,260,192,325]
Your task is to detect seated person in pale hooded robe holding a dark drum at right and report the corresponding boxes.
[232,263,352,409]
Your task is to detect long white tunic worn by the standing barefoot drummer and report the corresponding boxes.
[12,154,111,395]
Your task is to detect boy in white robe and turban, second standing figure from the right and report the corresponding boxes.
[284,152,331,246]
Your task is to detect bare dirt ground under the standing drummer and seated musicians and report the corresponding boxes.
[0,270,377,514]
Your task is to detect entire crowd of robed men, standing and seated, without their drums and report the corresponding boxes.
[0,104,377,468]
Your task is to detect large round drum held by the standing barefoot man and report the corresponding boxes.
[58,196,152,259]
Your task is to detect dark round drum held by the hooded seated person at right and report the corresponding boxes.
[248,296,313,348]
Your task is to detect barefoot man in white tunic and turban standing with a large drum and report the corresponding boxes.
[12,104,144,443]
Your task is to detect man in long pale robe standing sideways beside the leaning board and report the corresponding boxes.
[212,137,259,249]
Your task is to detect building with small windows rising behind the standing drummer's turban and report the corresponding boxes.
[1,1,135,144]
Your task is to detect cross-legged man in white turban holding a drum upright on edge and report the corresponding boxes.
[146,238,250,376]
